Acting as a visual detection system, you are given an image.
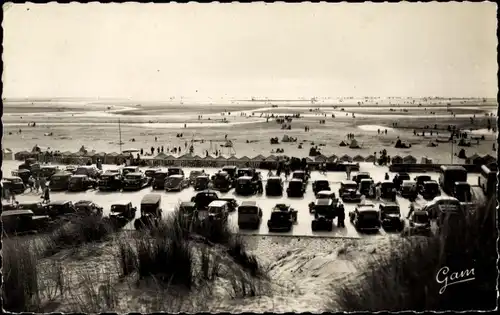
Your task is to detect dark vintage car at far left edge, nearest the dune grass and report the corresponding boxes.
[2,209,52,235]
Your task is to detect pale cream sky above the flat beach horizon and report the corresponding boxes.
[2,2,498,100]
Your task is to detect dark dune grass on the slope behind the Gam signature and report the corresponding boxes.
[330,199,498,312]
